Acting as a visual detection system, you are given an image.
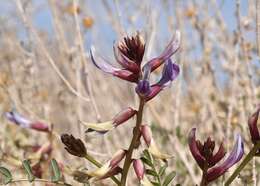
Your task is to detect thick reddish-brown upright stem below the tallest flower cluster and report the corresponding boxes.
[121,98,145,186]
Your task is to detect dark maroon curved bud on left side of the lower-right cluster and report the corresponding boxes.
[188,128,206,169]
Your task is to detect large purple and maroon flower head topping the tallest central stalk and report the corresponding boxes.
[90,31,180,101]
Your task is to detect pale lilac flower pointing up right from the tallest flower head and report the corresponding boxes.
[145,31,181,71]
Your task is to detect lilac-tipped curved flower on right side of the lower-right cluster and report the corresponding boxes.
[207,134,244,182]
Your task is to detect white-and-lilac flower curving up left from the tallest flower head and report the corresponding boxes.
[90,47,138,82]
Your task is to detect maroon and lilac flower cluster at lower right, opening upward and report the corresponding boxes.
[188,128,244,183]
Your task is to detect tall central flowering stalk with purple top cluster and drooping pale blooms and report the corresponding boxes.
[61,31,180,186]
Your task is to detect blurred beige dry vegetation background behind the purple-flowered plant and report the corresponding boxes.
[0,0,260,185]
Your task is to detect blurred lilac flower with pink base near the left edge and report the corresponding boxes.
[5,110,50,132]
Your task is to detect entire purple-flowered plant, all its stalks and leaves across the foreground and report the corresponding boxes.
[0,28,260,186]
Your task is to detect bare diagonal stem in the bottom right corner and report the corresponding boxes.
[225,142,260,186]
